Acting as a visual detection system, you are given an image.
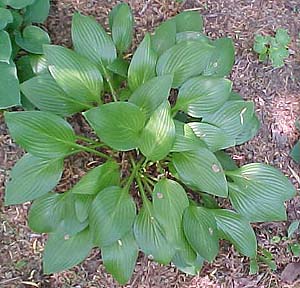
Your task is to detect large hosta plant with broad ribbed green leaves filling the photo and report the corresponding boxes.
[5,3,295,283]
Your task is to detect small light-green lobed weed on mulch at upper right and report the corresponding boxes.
[253,28,291,68]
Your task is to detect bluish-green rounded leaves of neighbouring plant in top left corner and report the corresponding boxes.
[0,0,50,109]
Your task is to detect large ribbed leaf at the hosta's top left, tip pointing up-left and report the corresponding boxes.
[72,13,117,73]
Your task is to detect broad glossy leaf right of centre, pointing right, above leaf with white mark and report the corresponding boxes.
[175,76,232,118]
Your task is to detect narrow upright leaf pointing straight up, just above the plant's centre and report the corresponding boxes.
[128,33,157,91]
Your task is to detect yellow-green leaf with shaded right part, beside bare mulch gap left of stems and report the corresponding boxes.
[72,161,120,195]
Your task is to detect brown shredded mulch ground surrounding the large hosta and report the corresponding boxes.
[0,0,300,288]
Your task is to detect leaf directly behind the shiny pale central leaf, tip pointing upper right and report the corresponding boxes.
[129,75,172,118]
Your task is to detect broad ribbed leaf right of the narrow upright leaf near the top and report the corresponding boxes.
[156,41,214,88]
